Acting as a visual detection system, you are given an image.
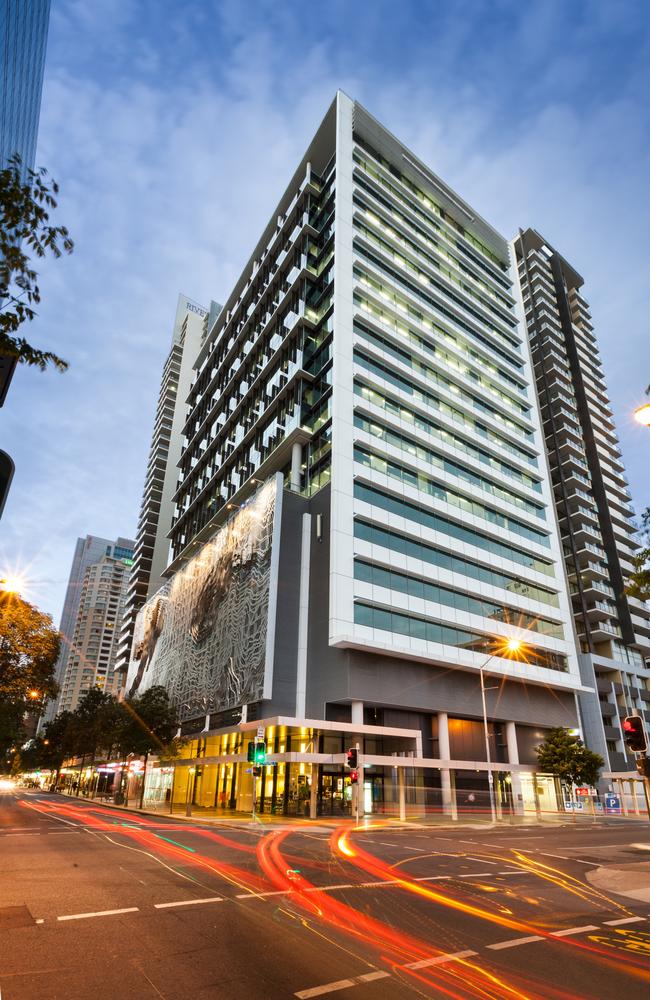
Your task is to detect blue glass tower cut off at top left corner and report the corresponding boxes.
[0,0,50,408]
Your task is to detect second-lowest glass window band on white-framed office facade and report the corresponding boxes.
[354,558,564,639]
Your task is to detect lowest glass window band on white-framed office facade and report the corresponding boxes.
[354,601,568,672]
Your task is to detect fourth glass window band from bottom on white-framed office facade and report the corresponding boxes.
[354,482,555,576]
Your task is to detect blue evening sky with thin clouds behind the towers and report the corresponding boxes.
[0,0,650,620]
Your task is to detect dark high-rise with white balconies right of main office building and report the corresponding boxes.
[515,229,650,780]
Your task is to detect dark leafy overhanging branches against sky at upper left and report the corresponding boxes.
[0,155,74,371]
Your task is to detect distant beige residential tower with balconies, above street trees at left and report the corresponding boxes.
[43,535,134,722]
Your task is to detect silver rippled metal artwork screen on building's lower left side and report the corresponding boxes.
[127,480,276,719]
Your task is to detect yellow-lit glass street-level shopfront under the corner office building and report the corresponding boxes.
[137,725,559,818]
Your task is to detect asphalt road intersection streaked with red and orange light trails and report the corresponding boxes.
[0,792,650,1000]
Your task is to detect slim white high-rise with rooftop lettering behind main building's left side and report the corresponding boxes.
[112,295,213,673]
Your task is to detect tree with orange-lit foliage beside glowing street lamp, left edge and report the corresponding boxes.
[0,591,61,758]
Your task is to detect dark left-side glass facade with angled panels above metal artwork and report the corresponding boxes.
[172,161,335,557]
